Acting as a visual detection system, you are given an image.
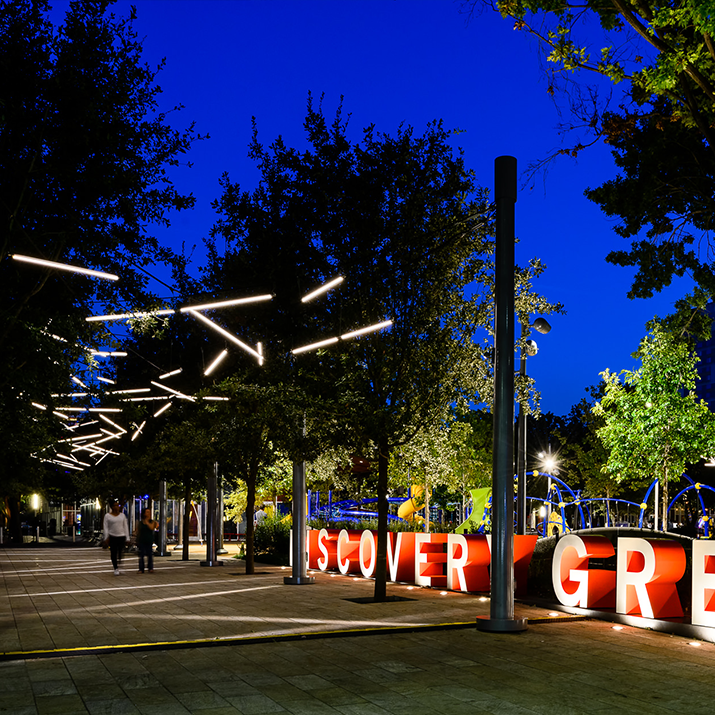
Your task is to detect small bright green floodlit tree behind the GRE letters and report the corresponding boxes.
[593,325,715,524]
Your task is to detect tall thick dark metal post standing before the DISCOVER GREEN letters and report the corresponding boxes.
[477,156,527,632]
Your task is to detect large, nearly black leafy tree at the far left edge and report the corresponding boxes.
[0,0,197,516]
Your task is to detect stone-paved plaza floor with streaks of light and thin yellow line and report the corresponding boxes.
[0,544,715,715]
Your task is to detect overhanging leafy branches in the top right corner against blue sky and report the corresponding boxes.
[464,0,715,308]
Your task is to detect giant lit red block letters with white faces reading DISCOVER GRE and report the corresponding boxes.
[296,529,715,642]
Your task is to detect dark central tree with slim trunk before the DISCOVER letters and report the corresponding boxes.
[204,98,560,599]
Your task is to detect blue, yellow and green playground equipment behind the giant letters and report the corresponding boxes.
[307,470,715,538]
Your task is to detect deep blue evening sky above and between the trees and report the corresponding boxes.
[56,0,687,414]
